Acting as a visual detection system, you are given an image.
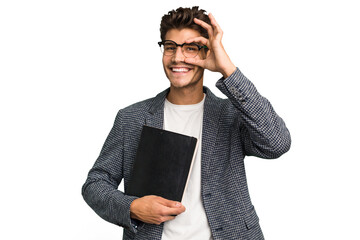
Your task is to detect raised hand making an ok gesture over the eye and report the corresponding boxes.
[185,13,236,78]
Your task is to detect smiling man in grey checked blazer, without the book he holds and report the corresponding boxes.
[82,7,291,240]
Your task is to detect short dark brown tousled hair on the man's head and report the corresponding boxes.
[160,6,211,41]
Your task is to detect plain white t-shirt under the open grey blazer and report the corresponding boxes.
[161,96,212,240]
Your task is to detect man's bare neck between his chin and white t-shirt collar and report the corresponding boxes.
[166,82,204,105]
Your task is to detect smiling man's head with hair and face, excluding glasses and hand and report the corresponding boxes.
[160,7,211,91]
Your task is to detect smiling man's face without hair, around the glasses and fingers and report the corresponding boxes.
[163,28,205,88]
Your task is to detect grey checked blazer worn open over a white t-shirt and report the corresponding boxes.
[82,69,291,240]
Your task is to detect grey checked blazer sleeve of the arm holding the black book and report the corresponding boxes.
[82,111,136,232]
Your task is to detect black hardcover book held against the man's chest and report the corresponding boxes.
[126,126,197,202]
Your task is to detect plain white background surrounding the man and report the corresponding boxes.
[0,0,360,240]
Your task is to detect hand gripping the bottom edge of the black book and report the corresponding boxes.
[130,195,185,225]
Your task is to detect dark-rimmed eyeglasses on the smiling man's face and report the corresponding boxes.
[158,40,208,58]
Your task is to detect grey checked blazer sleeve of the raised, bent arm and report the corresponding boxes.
[216,68,291,159]
